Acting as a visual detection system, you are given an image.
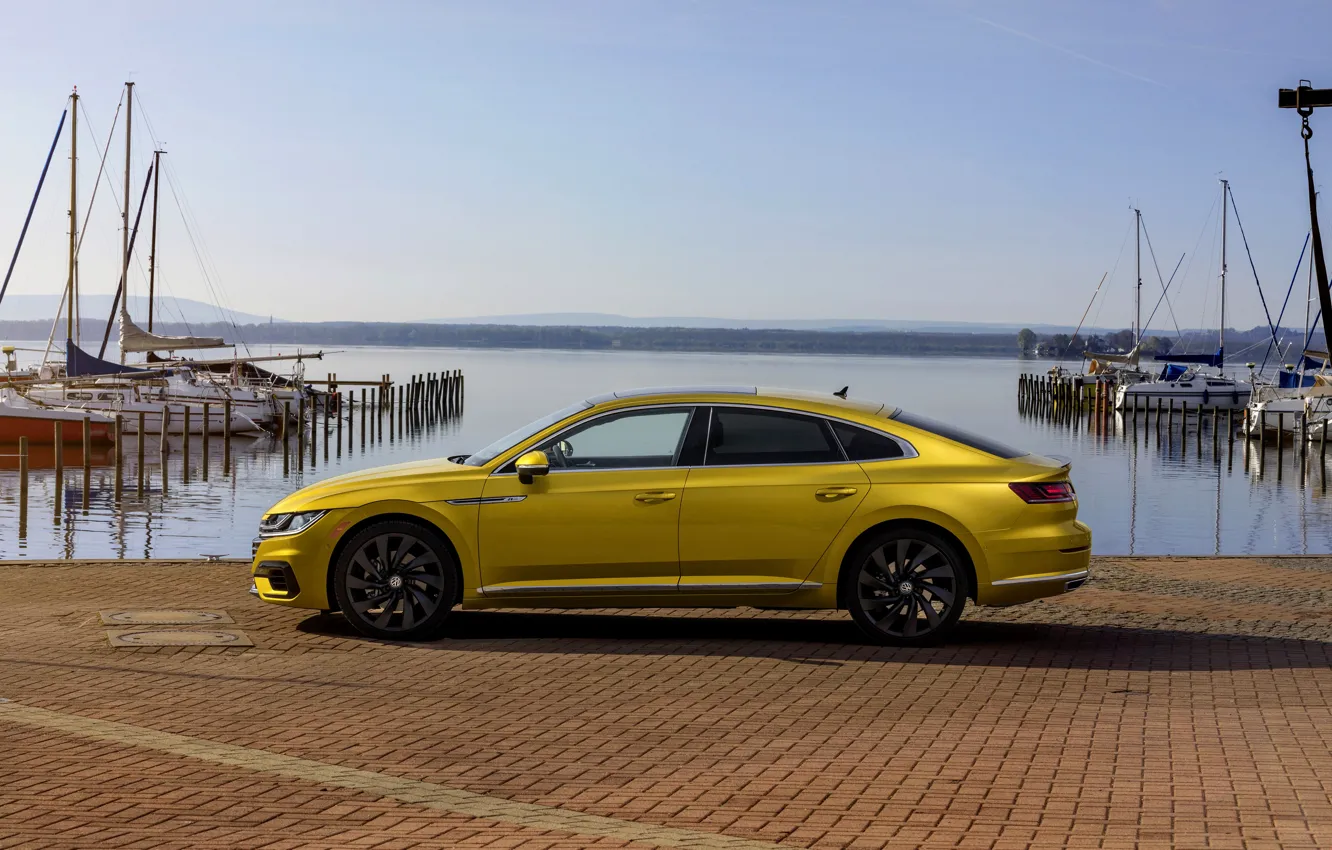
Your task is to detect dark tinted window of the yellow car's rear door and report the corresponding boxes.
[705,408,843,466]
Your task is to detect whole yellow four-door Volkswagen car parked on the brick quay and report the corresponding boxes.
[252,386,1091,645]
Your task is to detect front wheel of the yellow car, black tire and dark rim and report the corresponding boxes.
[333,520,458,641]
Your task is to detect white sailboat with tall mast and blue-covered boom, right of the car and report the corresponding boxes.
[1115,180,1253,410]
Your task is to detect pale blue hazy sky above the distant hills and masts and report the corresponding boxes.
[0,0,1332,328]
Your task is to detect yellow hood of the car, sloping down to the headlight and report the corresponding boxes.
[268,458,485,513]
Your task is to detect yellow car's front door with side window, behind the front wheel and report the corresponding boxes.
[478,405,694,596]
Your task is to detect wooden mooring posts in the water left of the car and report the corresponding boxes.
[9,369,464,533]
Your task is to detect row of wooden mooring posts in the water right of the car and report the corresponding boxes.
[1018,374,1328,474]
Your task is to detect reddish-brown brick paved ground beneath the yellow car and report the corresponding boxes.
[0,560,1332,850]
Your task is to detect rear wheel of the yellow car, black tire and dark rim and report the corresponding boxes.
[842,526,970,646]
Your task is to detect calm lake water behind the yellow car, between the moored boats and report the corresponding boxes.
[0,348,1332,558]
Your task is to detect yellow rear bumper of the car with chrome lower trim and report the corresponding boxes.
[976,521,1091,606]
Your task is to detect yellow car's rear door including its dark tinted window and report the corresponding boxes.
[679,406,870,593]
